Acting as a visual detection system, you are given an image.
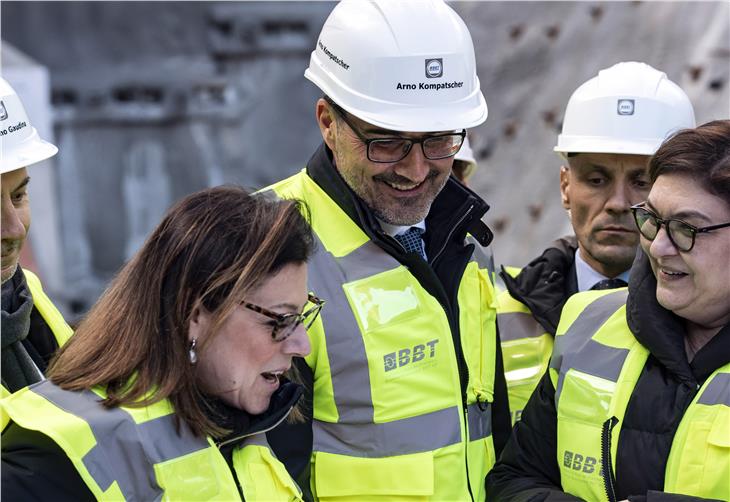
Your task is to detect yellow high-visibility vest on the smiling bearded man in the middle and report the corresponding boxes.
[270,171,499,501]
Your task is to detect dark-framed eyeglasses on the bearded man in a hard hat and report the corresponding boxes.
[327,100,466,163]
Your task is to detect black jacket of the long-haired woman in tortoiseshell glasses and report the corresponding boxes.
[0,382,302,502]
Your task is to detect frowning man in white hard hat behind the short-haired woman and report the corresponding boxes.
[498,62,695,421]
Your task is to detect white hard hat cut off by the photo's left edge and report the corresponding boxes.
[0,78,58,173]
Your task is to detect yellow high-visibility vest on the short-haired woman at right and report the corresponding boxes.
[549,288,730,501]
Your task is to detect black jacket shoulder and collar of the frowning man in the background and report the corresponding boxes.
[500,236,578,336]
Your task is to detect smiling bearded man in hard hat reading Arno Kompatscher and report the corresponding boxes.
[269,0,510,500]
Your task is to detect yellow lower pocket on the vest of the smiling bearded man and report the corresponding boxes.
[312,452,434,502]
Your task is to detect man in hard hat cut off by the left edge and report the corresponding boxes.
[0,78,71,408]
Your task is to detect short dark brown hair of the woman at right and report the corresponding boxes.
[649,120,730,204]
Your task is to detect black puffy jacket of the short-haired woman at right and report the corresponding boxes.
[487,252,730,502]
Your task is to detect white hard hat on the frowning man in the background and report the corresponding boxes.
[554,62,695,155]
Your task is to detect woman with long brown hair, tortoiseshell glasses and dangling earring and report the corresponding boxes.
[2,187,322,500]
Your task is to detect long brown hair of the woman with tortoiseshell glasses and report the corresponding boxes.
[48,186,313,435]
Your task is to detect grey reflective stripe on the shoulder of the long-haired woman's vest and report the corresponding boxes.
[30,381,209,501]
